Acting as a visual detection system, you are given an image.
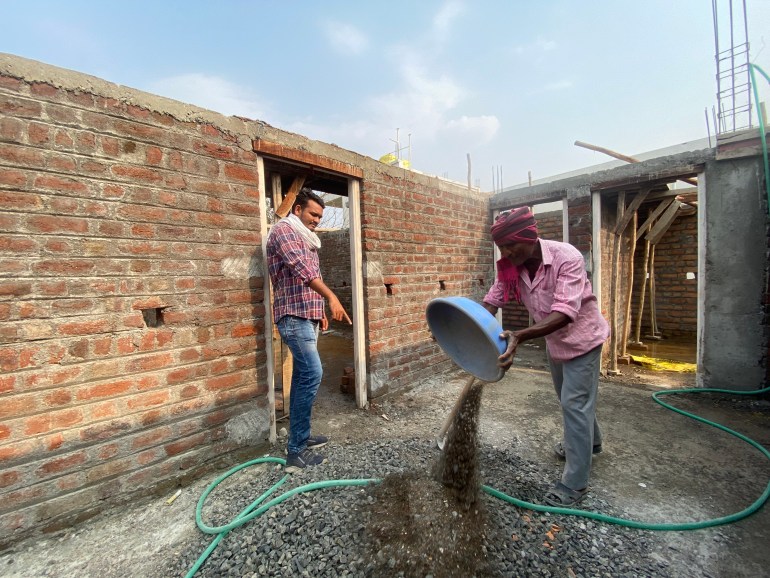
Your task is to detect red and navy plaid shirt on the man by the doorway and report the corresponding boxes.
[267,221,324,323]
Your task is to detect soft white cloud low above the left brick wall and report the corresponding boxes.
[148,72,265,120]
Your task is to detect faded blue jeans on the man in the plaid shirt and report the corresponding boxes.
[276,315,323,454]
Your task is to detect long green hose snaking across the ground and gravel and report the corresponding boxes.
[185,387,770,578]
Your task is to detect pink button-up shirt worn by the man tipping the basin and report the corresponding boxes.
[484,239,610,361]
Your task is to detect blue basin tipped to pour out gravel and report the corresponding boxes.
[425,297,507,381]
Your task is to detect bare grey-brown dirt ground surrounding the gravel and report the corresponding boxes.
[0,333,770,578]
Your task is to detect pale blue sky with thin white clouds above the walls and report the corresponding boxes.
[0,0,770,191]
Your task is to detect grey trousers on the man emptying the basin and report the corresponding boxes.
[548,345,602,490]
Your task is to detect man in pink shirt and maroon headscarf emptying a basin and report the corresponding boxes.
[484,207,609,506]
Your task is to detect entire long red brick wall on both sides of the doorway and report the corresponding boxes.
[0,55,492,547]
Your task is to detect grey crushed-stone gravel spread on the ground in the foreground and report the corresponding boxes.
[164,439,671,578]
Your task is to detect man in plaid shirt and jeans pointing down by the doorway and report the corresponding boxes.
[267,190,352,473]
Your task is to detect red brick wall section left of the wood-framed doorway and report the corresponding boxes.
[0,66,267,543]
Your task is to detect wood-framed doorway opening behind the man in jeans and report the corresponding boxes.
[257,155,367,442]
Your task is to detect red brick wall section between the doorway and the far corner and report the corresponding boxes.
[361,177,492,397]
